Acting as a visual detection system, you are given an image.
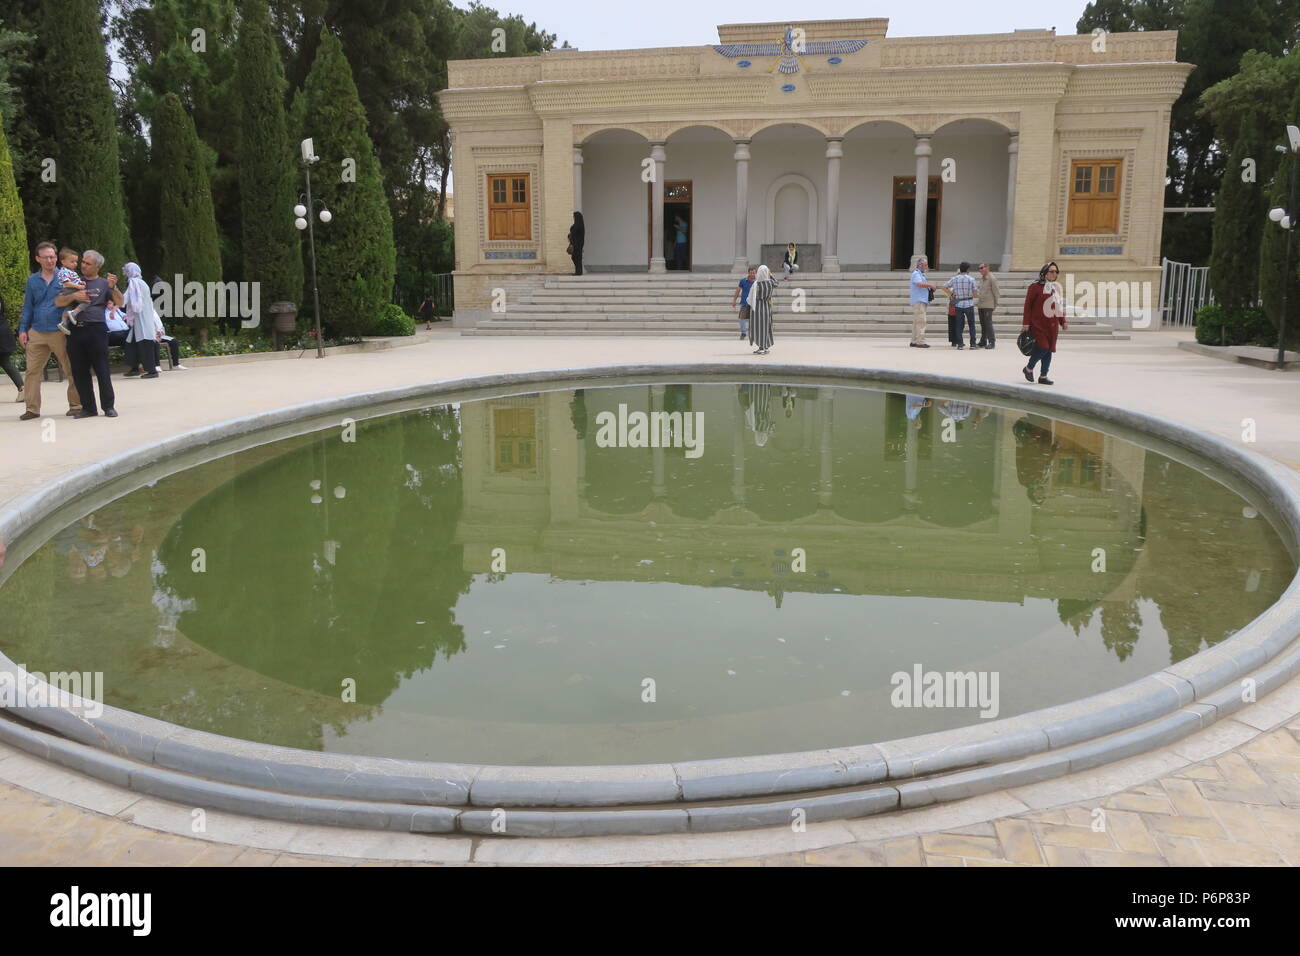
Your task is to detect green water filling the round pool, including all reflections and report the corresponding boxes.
[0,384,1296,765]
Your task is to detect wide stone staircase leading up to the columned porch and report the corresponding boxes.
[462,272,1127,342]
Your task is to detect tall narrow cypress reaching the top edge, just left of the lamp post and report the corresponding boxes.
[235,0,303,323]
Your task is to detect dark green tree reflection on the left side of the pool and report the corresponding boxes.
[159,407,471,723]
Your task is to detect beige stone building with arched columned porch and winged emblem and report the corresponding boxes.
[441,20,1192,321]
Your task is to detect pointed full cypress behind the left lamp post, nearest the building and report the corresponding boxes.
[294,30,397,336]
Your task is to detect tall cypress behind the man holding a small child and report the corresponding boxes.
[43,0,126,273]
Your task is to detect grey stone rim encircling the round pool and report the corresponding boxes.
[0,362,1300,836]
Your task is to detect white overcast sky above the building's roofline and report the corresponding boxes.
[491,0,1087,49]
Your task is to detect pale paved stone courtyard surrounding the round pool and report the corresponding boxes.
[0,326,1300,866]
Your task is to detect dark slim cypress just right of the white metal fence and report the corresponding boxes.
[1210,111,1275,308]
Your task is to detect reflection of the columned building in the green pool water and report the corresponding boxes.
[458,384,1145,617]
